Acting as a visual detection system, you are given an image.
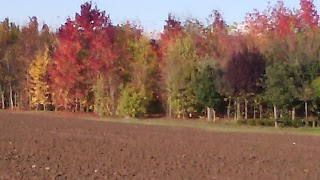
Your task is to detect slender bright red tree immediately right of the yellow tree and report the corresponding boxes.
[49,19,81,108]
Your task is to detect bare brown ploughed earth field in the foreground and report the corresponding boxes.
[0,111,320,180]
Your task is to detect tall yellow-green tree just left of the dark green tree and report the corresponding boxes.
[163,36,198,117]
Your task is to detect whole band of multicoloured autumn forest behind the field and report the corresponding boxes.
[0,0,320,126]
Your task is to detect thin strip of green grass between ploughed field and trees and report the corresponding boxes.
[8,111,320,136]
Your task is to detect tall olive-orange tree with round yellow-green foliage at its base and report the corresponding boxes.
[115,24,158,116]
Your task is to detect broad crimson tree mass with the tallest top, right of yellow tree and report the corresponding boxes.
[50,3,113,110]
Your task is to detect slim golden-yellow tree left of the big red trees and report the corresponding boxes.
[28,47,50,110]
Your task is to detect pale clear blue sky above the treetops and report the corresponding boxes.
[0,0,320,31]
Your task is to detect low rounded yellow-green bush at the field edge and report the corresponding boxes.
[118,87,148,117]
